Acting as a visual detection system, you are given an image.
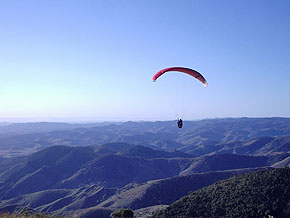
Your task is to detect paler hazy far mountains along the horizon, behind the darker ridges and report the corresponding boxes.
[0,118,290,157]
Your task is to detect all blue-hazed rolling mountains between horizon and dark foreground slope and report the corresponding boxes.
[0,118,290,218]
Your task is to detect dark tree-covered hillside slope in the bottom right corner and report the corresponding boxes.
[152,168,290,218]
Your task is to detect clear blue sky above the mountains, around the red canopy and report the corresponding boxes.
[0,0,290,121]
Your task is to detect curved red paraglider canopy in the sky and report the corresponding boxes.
[152,67,207,87]
